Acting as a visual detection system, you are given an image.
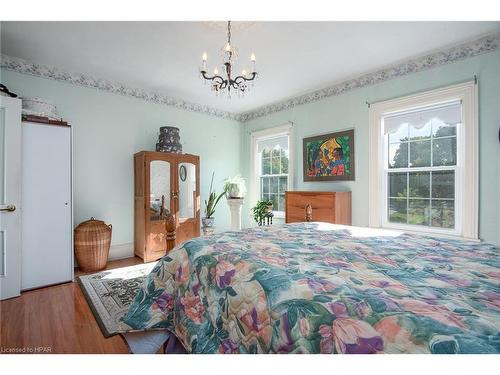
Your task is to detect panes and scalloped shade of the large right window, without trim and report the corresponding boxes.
[382,102,462,229]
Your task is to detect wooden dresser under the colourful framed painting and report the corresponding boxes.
[285,191,351,225]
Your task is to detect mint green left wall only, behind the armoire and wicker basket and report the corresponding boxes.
[0,70,241,245]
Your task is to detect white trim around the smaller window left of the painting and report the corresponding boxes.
[250,122,295,218]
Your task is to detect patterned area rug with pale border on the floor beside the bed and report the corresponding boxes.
[78,262,156,337]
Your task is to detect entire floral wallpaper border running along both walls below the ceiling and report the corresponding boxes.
[0,33,500,122]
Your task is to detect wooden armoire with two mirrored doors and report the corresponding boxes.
[134,151,200,262]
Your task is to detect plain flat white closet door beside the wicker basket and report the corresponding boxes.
[21,123,73,289]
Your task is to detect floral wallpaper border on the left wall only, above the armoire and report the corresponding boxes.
[0,54,239,120]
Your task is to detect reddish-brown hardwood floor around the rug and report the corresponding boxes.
[0,257,142,354]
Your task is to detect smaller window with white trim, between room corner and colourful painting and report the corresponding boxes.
[252,124,292,217]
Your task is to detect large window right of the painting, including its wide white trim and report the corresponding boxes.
[369,83,478,238]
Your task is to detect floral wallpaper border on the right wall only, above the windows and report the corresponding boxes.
[238,33,500,122]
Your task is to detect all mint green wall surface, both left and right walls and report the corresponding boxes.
[0,51,500,250]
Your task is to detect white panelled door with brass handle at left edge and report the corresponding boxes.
[0,96,21,299]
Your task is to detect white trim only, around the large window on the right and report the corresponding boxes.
[368,81,479,240]
